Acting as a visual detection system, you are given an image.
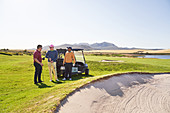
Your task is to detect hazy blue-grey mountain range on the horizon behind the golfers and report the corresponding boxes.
[38,42,160,51]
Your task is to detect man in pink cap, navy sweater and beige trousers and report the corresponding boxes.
[46,45,59,82]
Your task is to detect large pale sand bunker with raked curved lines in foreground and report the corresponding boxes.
[55,74,170,113]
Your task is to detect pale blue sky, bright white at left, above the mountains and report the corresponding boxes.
[0,0,170,49]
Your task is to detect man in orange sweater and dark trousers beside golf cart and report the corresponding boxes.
[63,47,76,80]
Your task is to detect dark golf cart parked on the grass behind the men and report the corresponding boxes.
[56,49,89,76]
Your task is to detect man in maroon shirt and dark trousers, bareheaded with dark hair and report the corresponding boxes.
[33,45,43,84]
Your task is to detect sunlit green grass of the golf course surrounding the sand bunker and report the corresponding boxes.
[0,55,170,113]
